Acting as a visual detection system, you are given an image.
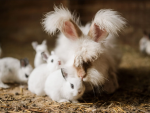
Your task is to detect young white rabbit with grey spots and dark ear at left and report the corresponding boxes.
[0,57,32,88]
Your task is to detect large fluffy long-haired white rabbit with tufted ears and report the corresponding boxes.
[43,7,126,93]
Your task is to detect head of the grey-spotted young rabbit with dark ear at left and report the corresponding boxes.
[18,58,33,82]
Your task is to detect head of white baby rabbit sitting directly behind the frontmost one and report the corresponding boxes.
[41,51,62,69]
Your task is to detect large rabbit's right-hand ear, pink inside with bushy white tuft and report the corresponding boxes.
[88,9,126,42]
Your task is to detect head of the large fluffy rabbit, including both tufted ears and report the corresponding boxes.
[43,7,126,85]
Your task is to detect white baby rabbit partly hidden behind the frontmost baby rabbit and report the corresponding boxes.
[28,52,62,96]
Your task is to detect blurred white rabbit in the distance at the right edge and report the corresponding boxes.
[139,31,149,53]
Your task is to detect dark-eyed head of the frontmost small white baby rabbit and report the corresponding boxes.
[61,68,85,100]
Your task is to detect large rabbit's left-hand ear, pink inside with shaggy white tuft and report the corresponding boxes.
[42,7,82,40]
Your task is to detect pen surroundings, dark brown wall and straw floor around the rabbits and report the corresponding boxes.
[0,0,150,113]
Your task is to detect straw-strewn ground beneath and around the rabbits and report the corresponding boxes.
[0,40,150,113]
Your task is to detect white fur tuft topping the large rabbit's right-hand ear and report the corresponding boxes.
[93,9,126,35]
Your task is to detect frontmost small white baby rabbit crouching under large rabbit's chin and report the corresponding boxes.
[44,69,85,103]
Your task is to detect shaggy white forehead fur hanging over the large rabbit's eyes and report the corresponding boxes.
[75,38,103,67]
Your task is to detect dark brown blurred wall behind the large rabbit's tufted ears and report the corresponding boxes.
[0,0,150,46]
